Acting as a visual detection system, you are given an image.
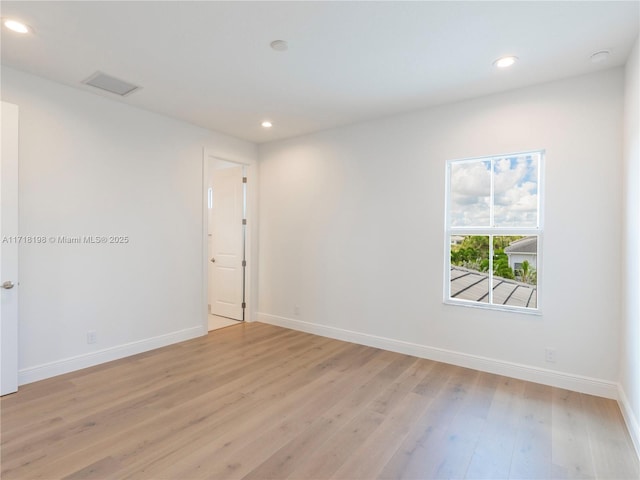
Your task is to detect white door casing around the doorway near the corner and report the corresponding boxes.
[201,148,258,334]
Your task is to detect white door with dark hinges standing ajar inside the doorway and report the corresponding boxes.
[209,166,244,320]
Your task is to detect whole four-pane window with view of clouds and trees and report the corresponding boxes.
[444,151,544,313]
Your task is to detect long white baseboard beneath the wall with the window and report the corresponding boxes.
[256,312,618,400]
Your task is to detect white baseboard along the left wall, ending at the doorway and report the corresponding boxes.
[18,326,207,385]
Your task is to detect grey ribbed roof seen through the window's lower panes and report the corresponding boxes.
[450,266,538,308]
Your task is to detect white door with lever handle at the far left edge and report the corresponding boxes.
[0,102,18,395]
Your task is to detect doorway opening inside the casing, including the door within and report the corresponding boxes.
[205,155,248,331]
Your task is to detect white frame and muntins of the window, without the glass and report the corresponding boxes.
[443,149,546,315]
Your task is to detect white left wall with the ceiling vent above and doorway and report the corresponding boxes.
[2,67,256,383]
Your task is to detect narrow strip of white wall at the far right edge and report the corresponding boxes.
[620,35,640,455]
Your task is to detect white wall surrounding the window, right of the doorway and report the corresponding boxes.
[258,69,623,396]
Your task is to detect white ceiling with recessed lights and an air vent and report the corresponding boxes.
[1,0,640,143]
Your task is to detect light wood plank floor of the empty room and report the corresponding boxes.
[0,323,639,480]
